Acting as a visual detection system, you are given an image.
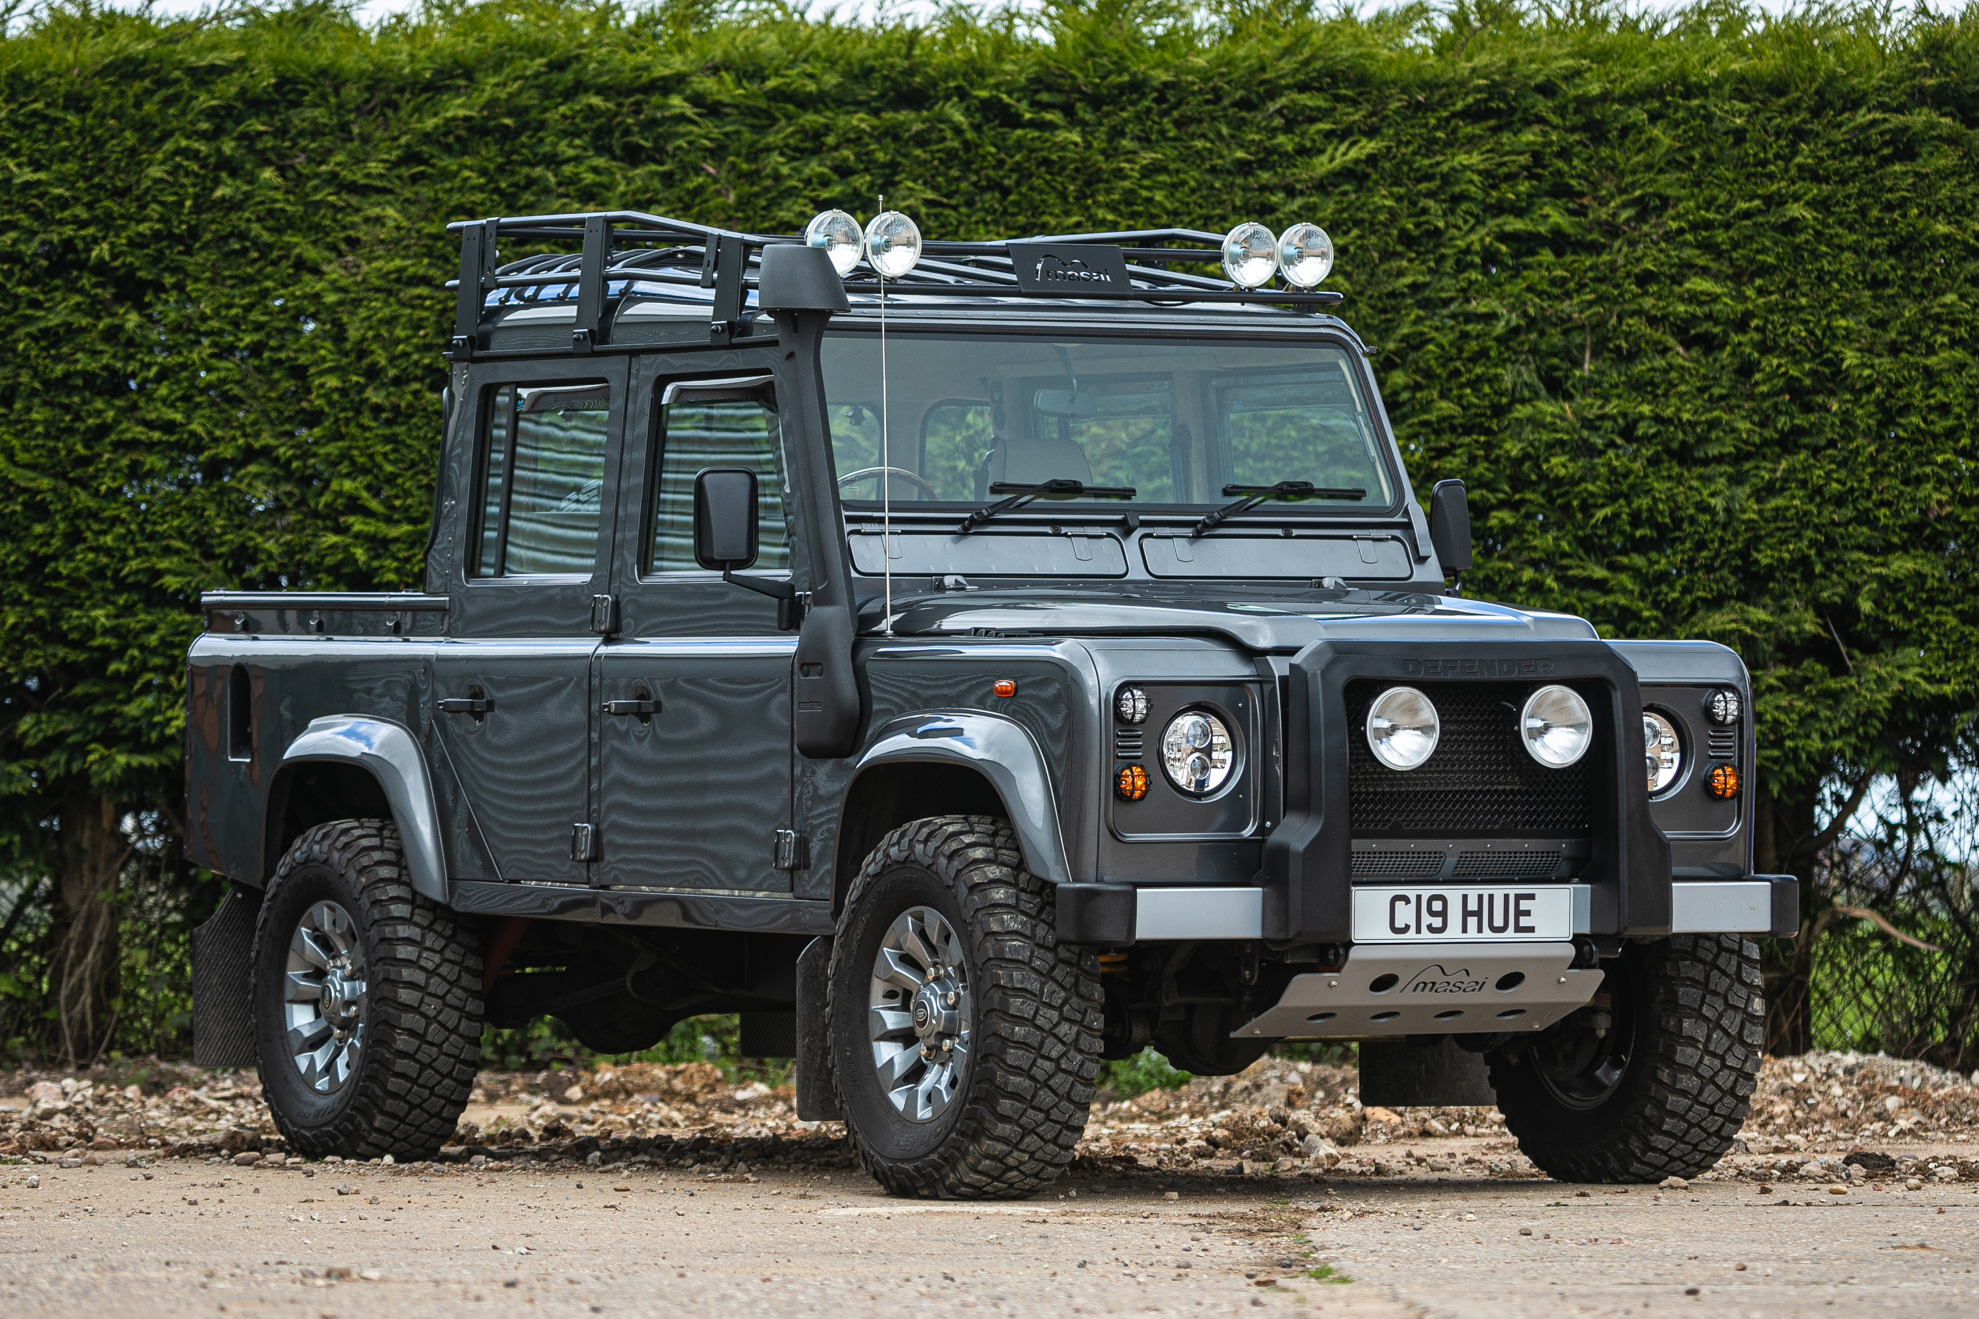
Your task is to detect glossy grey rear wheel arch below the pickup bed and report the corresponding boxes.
[261,715,447,903]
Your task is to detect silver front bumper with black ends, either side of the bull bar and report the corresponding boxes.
[1057,875,1801,947]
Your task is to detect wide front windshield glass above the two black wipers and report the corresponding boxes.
[823,333,1395,513]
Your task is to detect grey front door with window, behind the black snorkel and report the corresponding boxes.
[598,355,798,895]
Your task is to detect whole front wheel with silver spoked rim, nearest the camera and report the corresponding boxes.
[825,816,1102,1200]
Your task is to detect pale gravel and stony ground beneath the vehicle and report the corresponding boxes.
[0,1056,1979,1319]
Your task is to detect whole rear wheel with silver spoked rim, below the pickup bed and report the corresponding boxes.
[251,820,481,1159]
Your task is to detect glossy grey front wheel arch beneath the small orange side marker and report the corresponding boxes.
[831,711,1071,919]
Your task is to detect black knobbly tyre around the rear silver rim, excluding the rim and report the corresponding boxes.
[251,820,481,1161]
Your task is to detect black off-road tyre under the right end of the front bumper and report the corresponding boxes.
[1486,935,1765,1182]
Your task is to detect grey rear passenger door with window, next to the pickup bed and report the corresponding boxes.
[431,360,625,883]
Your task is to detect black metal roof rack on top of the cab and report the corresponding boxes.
[447,210,1342,351]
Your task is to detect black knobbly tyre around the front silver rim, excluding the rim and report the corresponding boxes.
[825,816,1102,1200]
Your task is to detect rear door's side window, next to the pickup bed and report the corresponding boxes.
[475,384,612,576]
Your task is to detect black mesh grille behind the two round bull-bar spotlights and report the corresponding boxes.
[1346,679,1595,838]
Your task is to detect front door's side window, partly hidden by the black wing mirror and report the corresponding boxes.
[645,400,790,572]
